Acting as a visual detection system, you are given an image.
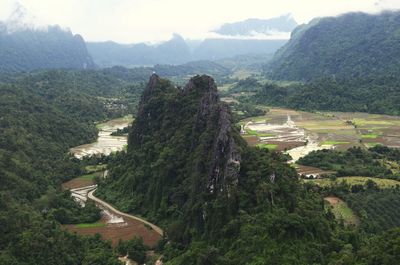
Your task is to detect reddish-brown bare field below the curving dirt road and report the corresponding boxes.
[64,211,161,247]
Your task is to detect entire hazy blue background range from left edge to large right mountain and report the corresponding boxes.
[0,6,290,72]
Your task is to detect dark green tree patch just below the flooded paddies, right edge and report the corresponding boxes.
[297,145,400,180]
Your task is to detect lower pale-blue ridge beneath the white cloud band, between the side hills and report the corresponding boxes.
[87,34,287,67]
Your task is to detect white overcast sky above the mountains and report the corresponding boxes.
[0,0,400,43]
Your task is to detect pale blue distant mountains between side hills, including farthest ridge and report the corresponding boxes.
[87,15,297,67]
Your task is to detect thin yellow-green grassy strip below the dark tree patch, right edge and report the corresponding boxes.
[304,176,400,189]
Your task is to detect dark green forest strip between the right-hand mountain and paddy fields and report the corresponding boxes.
[247,76,400,115]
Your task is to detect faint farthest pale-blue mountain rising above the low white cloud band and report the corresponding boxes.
[214,14,298,36]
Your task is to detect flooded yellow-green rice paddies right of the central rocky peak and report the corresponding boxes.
[241,108,400,151]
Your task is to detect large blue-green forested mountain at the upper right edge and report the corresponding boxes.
[269,12,400,81]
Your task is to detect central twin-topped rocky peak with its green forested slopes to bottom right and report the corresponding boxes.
[96,75,400,265]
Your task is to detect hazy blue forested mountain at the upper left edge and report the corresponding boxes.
[0,22,94,72]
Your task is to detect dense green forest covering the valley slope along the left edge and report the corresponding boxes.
[0,70,148,265]
